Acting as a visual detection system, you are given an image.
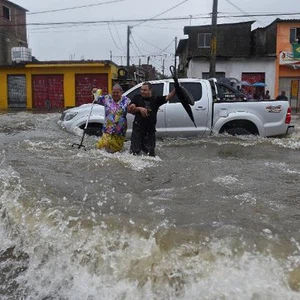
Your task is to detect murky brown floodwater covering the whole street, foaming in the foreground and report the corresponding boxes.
[0,112,300,300]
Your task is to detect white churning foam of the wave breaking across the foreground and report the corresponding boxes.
[0,150,300,300]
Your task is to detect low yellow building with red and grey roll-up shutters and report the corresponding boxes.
[0,61,118,109]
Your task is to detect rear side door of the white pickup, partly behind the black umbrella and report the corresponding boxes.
[165,81,209,136]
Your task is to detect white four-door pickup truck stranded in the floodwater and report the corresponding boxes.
[58,78,294,137]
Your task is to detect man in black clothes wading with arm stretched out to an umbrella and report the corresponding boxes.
[128,82,175,156]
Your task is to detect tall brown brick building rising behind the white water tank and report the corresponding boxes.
[0,0,28,65]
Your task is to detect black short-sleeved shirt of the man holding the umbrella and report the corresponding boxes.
[130,95,166,132]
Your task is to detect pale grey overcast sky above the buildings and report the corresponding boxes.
[11,0,300,74]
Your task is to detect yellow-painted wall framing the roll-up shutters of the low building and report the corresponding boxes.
[0,63,117,109]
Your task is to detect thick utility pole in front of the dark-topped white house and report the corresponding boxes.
[209,0,218,78]
